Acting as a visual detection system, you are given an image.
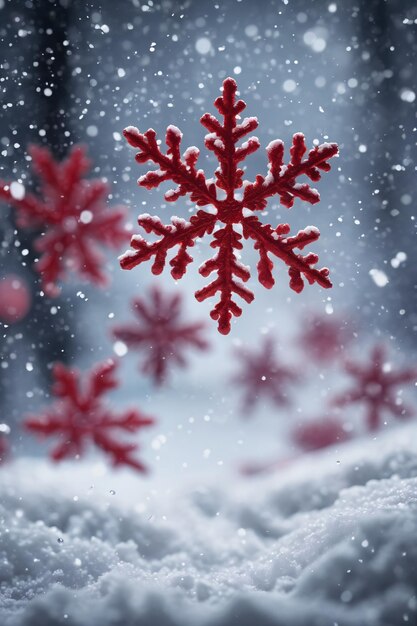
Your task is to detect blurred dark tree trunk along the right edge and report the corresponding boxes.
[355,0,417,340]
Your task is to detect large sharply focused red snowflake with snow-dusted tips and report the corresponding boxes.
[120,78,338,334]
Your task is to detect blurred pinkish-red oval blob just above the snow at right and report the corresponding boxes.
[292,417,352,452]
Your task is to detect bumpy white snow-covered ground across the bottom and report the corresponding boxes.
[0,424,417,626]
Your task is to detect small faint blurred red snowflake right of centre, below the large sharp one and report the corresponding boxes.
[232,338,299,413]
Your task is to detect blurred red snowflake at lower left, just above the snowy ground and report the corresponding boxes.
[24,360,154,472]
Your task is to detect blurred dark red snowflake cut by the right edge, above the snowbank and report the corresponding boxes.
[332,346,417,431]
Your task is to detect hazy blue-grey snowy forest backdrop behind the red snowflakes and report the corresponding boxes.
[0,0,417,474]
